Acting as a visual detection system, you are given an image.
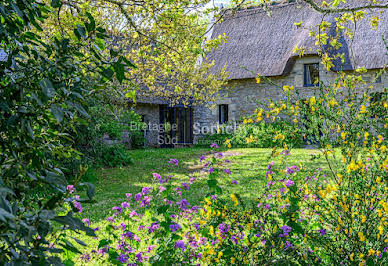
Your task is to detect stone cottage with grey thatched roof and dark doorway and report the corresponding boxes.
[135,2,388,146]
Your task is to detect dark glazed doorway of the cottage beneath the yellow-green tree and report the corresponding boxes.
[159,105,193,147]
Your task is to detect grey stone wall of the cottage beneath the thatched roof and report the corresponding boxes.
[194,56,388,141]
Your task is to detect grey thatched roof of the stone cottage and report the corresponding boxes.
[208,3,388,79]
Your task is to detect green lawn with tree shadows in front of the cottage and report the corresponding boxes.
[82,148,325,221]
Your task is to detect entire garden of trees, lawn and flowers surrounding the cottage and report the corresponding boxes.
[0,0,388,265]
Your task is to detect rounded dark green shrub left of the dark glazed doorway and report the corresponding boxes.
[74,102,144,166]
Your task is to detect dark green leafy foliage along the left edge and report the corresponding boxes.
[0,0,133,264]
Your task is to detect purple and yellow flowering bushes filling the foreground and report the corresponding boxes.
[59,69,388,265]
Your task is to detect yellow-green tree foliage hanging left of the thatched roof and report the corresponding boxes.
[45,0,227,105]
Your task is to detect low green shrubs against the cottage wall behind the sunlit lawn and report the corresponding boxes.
[199,120,302,148]
